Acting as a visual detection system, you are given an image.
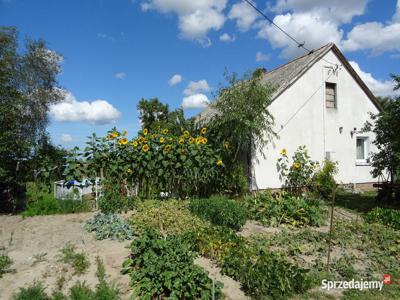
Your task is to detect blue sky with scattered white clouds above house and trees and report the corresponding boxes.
[0,0,400,148]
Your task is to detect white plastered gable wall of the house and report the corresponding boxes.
[253,51,378,189]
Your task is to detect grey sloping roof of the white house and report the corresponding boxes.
[197,43,381,121]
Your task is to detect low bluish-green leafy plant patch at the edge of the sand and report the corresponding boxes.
[85,213,133,241]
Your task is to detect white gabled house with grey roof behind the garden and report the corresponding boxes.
[199,43,380,190]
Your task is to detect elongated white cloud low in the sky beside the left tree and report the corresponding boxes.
[50,91,121,124]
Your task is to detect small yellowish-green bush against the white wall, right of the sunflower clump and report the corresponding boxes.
[311,160,338,199]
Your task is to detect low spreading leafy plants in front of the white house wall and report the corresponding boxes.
[244,192,325,227]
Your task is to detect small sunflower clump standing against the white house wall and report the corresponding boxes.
[278,146,317,196]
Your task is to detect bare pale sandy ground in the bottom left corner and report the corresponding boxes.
[0,213,130,299]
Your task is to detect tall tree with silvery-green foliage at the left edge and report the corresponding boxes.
[0,27,62,210]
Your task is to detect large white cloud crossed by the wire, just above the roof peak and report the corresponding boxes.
[257,12,343,58]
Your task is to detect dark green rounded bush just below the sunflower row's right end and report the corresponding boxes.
[189,196,247,230]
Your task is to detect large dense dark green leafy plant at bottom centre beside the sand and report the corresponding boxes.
[123,231,221,299]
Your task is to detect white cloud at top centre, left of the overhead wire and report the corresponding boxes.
[141,0,227,42]
